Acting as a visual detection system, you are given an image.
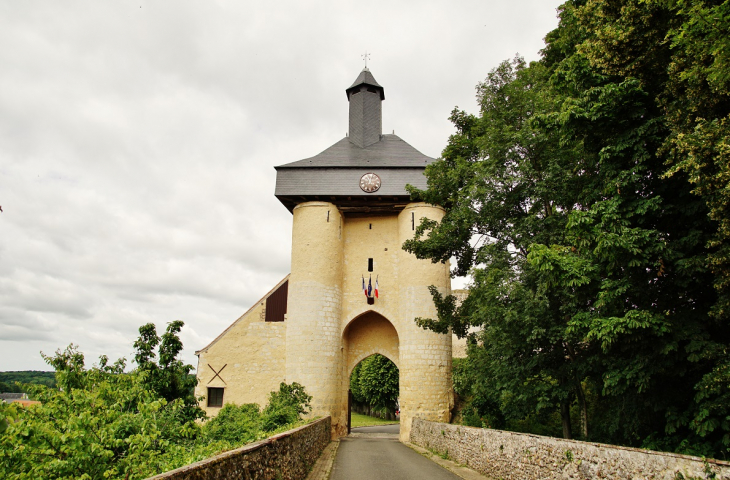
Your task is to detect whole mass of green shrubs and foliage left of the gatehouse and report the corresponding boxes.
[0,325,311,480]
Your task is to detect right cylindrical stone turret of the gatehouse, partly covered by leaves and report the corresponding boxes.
[398,203,454,441]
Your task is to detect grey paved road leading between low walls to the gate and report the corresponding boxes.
[330,425,460,480]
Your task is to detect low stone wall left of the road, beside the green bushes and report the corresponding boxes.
[148,417,332,480]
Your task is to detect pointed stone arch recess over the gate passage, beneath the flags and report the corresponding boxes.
[338,310,400,435]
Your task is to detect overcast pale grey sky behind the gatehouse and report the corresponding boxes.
[0,0,561,370]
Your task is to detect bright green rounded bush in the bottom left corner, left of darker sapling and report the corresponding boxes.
[0,345,197,479]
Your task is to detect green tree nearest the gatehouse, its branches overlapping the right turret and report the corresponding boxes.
[404,58,587,438]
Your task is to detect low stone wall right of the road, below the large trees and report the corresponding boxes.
[410,418,730,480]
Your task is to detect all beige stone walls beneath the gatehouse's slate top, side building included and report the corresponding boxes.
[199,202,453,439]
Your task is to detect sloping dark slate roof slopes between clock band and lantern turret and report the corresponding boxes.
[275,135,436,170]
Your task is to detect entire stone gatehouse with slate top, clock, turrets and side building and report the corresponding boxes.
[196,68,453,439]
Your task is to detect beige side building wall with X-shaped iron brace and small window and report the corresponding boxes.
[195,279,287,416]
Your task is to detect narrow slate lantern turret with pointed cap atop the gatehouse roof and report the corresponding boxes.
[345,67,385,148]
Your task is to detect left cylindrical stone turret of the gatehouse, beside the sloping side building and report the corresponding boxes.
[286,202,343,426]
